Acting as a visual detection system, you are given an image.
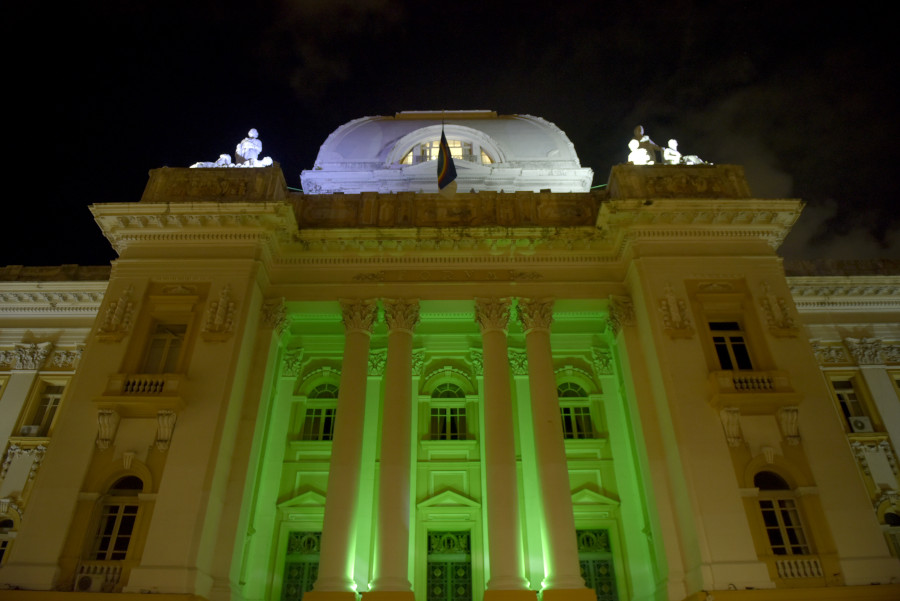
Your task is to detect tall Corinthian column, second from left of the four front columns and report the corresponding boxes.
[367,299,419,601]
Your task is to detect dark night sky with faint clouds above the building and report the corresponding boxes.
[8,0,900,265]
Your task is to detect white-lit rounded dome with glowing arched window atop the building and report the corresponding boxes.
[301,111,593,194]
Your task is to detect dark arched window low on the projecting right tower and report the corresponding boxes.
[753,471,810,555]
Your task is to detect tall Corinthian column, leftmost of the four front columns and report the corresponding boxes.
[306,300,377,601]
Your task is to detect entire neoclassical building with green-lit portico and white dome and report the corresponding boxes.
[0,112,900,601]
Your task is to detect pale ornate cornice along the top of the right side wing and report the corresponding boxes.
[787,275,900,313]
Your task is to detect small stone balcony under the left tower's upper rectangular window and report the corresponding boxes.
[94,374,186,417]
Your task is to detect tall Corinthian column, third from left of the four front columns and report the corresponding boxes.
[475,298,536,601]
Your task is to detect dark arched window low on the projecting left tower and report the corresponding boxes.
[90,476,144,561]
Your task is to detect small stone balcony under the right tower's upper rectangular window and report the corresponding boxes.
[709,370,801,415]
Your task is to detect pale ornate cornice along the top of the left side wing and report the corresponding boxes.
[0,281,108,316]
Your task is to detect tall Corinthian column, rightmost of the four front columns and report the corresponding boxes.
[519,299,595,601]
